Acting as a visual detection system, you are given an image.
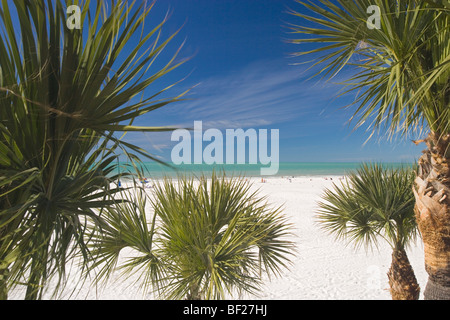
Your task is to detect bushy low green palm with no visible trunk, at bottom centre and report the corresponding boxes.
[153,174,293,299]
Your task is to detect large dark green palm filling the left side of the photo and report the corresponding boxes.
[0,0,183,299]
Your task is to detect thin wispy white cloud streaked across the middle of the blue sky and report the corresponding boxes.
[169,62,338,129]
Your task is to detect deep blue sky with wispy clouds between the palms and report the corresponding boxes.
[122,0,424,162]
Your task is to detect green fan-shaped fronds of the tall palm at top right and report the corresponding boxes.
[291,0,450,139]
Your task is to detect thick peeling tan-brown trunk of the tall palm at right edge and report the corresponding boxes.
[414,132,450,300]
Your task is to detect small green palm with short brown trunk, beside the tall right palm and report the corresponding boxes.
[317,164,420,300]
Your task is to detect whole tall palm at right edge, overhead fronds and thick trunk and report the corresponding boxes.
[292,0,450,299]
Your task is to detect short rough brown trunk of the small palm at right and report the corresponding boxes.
[388,249,420,300]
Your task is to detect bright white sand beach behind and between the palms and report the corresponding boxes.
[10,176,427,300]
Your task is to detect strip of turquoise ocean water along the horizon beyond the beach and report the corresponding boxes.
[116,162,412,179]
